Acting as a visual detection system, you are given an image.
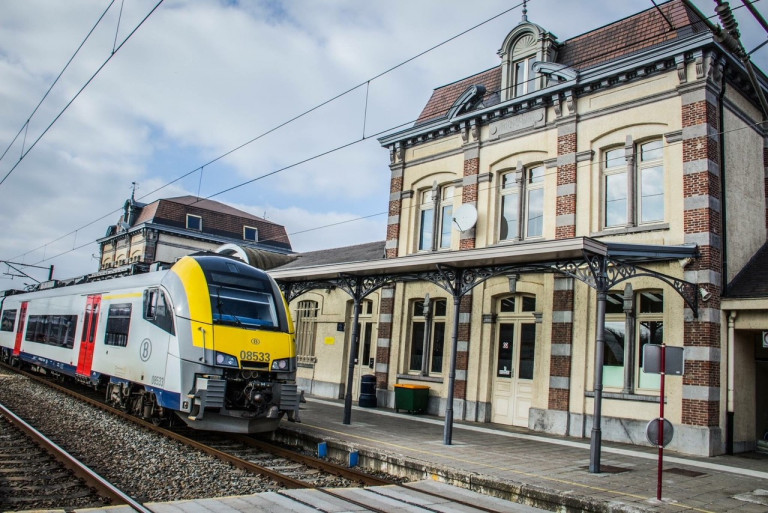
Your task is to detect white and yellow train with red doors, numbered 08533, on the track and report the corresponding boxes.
[0,253,301,434]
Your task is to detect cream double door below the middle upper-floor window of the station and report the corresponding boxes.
[491,297,536,427]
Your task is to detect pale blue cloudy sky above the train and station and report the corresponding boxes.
[0,0,768,289]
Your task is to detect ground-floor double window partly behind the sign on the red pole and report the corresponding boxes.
[603,290,664,393]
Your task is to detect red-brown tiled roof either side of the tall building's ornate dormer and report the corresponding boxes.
[416,0,709,125]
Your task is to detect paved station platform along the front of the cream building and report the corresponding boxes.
[278,397,768,513]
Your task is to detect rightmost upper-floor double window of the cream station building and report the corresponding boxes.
[601,139,664,228]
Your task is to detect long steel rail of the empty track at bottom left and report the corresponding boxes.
[0,403,152,513]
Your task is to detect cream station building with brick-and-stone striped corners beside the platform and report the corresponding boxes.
[271,0,768,456]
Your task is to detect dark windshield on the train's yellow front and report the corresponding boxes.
[209,280,279,329]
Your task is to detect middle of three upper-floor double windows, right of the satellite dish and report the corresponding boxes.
[499,165,544,240]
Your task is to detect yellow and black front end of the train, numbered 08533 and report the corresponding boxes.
[162,255,299,433]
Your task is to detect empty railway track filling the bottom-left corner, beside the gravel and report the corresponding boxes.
[0,404,149,512]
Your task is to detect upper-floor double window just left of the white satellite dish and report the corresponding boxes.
[418,184,455,251]
